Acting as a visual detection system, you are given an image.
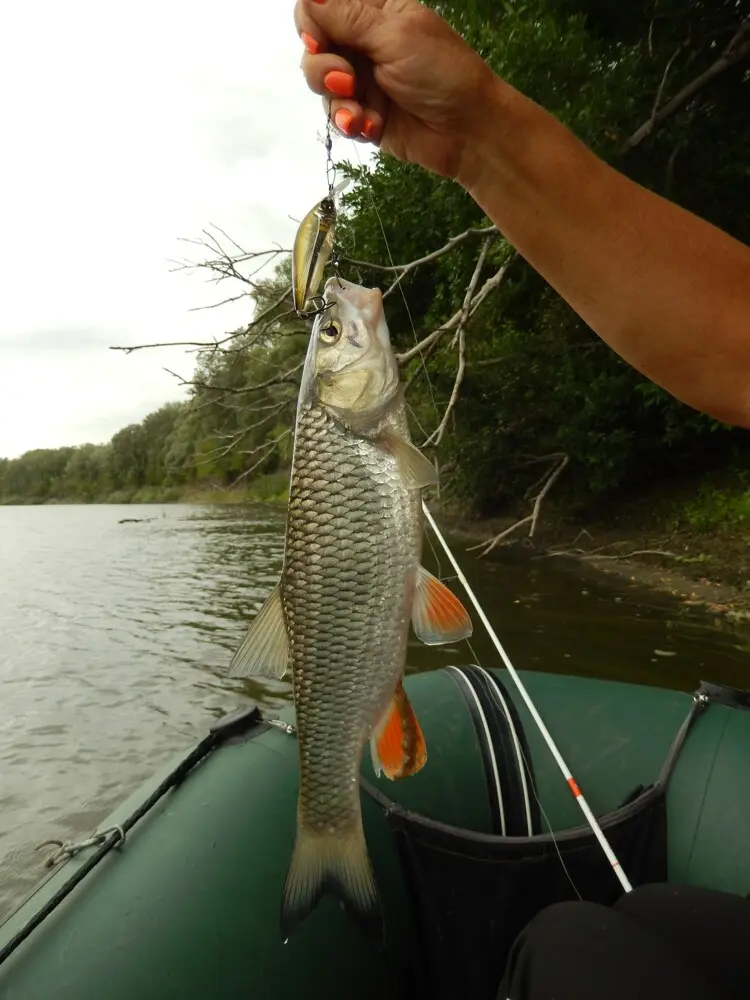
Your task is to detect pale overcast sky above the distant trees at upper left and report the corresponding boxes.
[0,0,370,457]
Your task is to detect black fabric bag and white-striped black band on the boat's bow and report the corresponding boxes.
[362,668,701,1000]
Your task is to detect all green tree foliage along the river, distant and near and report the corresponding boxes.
[0,0,750,526]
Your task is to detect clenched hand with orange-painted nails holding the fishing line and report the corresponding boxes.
[294,0,497,181]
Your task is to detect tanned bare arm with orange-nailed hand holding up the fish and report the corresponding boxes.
[295,0,750,427]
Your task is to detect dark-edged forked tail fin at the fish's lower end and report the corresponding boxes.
[280,824,382,939]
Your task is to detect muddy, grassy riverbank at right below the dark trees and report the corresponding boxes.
[442,473,750,624]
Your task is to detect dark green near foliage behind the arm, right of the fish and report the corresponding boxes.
[345,0,750,513]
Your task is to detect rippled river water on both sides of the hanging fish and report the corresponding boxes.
[0,504,750,916]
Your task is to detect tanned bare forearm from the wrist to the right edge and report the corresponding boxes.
[459,79,750,427]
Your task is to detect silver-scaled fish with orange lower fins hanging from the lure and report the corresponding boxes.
[229,277,472,938]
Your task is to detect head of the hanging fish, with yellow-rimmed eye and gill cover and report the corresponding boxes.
[303,277,399,421]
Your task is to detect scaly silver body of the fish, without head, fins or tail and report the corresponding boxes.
[282,405,422,834]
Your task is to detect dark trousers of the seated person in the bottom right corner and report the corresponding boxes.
[498,884,750,1000]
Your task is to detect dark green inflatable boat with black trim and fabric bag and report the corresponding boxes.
[0,666,750,1000]
